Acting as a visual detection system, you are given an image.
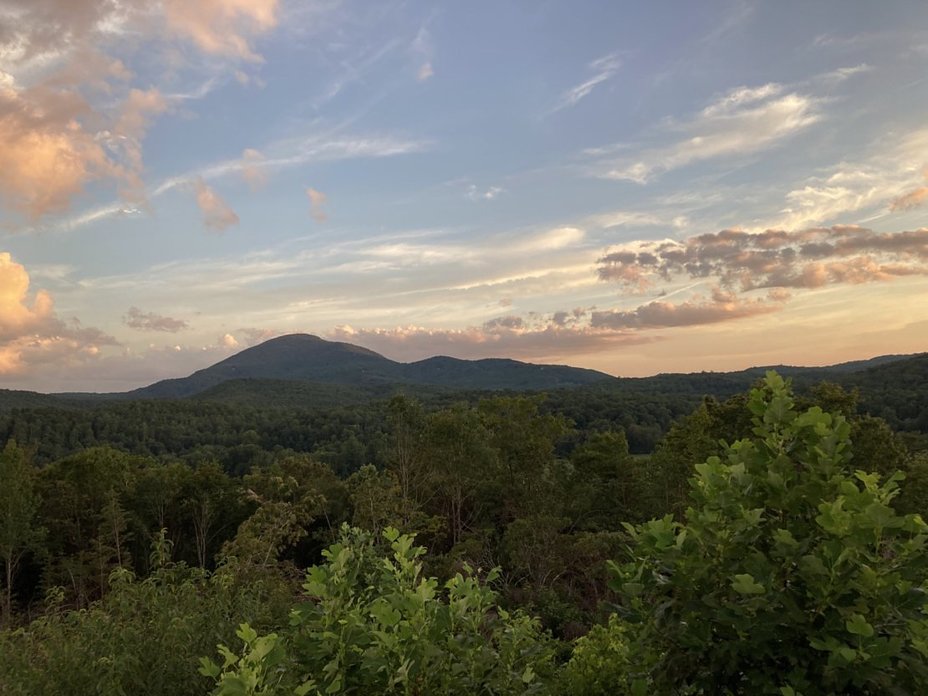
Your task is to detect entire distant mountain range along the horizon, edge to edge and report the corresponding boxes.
[0,334,928,409]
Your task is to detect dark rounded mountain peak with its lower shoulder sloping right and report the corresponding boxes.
[125,334,615,399]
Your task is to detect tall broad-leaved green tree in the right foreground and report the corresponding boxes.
[612,373,928,696]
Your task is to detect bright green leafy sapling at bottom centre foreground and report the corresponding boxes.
[202,526,552,696]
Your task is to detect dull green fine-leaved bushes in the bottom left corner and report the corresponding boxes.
[0,564,289,696]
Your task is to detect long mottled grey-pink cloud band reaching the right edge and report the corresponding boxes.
[598,226,928,292]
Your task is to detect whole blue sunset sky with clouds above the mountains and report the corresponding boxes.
[0,0,928,391]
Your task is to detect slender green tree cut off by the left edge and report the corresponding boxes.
[0,440,44,623]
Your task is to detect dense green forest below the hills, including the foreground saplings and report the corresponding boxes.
[0,370,928,694]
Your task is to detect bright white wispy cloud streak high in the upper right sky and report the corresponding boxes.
[591,83,821,184]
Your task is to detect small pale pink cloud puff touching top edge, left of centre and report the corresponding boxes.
[164,0,278,61]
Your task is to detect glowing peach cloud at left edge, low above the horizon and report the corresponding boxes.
[0,252,116,376]
